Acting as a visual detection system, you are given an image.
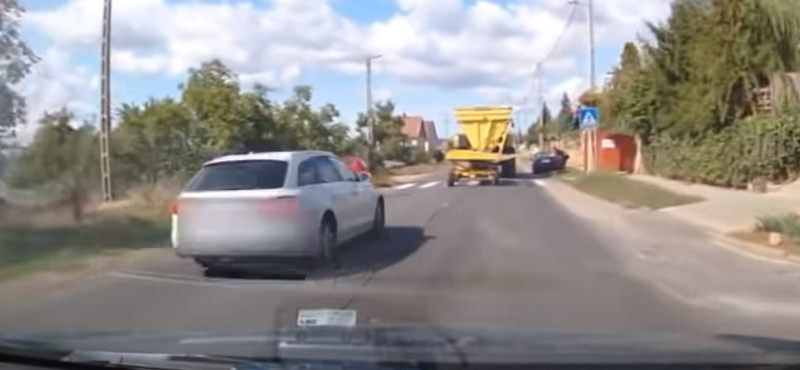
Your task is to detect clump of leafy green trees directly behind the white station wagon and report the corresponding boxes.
[112,61,356,194]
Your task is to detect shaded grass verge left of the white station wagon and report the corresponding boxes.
[0,213,170,280]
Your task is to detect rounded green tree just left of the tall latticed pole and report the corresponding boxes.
[9,109,99,221]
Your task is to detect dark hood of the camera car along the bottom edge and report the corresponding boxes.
[0,326,800,364]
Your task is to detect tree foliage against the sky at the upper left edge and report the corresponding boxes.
[0,0,39,130]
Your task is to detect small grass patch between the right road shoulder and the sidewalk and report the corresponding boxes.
[559,168,703,209]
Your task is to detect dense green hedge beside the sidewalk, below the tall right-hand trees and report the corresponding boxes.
[643,114,800,188]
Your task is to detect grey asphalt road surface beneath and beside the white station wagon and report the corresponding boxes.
[0,172,800,336]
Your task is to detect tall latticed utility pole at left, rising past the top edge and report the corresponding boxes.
[100,0,113,202]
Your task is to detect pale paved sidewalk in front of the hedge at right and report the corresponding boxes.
[631,175,800,234]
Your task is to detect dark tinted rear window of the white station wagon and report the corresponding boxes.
[186,160,288,192]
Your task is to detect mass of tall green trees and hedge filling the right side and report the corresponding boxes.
[601,0,800,186]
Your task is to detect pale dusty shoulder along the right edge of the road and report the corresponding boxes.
[536,177,800,319]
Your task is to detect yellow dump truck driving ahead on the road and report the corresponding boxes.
[445,106,517,186]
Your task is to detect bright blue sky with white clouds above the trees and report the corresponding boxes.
[15,0,668,142]
